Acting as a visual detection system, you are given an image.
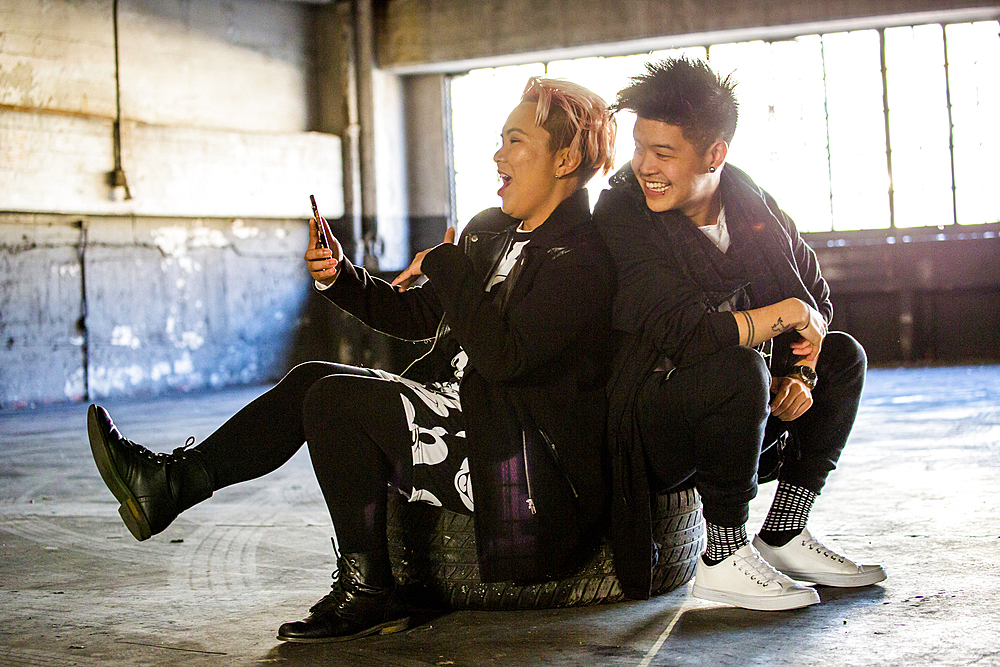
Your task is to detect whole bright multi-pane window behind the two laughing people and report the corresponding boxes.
[451,21,1000,233]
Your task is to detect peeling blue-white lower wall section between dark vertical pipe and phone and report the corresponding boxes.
[84,218,309,398]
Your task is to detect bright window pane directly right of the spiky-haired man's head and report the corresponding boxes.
[709,35,833,231]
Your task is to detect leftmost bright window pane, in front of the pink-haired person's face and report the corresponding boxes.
[451,63,544,231]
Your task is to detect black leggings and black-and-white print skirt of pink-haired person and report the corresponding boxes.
[190,361,471,553]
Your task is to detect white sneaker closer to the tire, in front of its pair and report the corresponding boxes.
[691,544,819,611]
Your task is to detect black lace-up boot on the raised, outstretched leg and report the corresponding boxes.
[87,405,213,540]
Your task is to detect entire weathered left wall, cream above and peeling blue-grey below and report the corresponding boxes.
[0,0,352,407]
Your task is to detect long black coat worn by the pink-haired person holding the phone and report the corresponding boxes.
[322,190,613,581]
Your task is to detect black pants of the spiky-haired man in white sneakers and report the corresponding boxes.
[639,332,867,526]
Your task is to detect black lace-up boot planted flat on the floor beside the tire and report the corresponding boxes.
[278,553,410,643]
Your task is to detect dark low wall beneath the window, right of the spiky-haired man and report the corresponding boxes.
[807,230,1000,365]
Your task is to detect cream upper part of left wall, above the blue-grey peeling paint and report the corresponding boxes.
[0,0,343,218]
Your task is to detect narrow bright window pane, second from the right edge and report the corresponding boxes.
[885,25,955,228]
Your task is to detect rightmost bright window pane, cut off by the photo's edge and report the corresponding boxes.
[946,21,1000,225]
